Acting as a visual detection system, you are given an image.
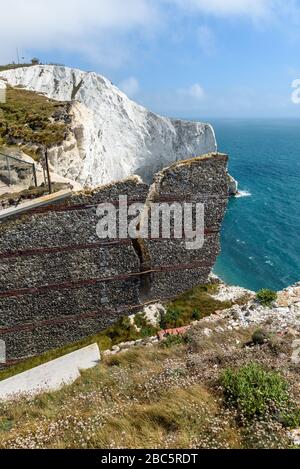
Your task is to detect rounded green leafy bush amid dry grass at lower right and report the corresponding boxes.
[221,363,289,420]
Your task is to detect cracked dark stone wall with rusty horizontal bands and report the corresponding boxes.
[0,153,228,365]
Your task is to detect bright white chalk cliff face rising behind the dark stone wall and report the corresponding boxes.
[0,65,217,186]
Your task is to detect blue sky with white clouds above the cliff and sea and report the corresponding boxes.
[0,0,300,118]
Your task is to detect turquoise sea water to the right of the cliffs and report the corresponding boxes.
[206,119,300,290]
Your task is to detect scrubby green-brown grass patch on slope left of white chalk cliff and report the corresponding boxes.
[0,86,69,151]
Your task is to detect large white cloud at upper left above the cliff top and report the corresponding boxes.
[0,0,159,66]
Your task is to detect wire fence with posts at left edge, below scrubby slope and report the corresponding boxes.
[0,152,37,187]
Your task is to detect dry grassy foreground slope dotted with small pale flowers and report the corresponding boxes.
[0,330,296,449]
